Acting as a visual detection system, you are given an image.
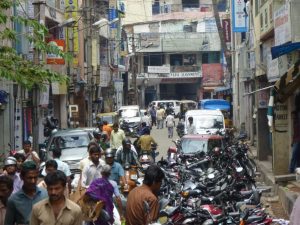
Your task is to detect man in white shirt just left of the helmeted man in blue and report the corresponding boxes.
[81,146,105,188]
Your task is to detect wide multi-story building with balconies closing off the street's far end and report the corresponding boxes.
[124,0,227,107]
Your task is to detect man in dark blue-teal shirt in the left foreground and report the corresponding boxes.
[4,161,48,225]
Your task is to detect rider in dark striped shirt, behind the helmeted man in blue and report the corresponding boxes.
[115,139,139,168]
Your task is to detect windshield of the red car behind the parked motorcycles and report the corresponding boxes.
[181,138,222,154]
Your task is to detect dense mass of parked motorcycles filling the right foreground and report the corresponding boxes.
[145,134,288,225]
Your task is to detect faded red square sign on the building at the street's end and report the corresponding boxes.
[202,63,223,87]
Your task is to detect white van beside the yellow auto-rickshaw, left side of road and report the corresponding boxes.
[118,105,142,125]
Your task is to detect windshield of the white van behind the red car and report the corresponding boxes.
[193,115,224,130]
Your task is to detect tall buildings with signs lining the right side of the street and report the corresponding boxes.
[233,0,300,175]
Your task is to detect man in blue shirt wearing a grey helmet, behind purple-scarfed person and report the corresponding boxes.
[105,148,127,184]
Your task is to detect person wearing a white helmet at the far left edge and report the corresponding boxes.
[3,156,23,193]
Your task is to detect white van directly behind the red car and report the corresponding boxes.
[184,109,225,134]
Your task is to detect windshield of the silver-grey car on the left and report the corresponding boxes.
[51,134,90,149]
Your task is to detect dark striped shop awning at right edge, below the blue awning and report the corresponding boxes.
[274,59,300,102]
